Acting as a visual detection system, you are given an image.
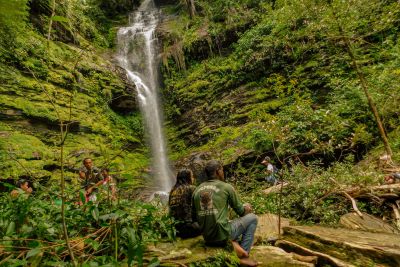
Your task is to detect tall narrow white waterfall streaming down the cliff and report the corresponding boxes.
[117,0,173,192]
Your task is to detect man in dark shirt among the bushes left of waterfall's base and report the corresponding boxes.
[79,158,104,201]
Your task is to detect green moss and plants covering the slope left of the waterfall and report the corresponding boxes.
[0,0,148,182]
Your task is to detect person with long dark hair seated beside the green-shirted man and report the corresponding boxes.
[168,169,201,238]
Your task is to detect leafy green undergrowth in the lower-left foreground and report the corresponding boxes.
[0,187,174,266]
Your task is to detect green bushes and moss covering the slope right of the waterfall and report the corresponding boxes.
[160,0,400,231]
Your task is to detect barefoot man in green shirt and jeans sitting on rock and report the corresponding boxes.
[193,160,258,266]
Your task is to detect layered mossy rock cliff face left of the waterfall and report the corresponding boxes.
[0,0,148,186]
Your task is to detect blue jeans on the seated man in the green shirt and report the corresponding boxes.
[230,213,258,253]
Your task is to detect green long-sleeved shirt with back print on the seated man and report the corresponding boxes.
[193,180,244,242]
